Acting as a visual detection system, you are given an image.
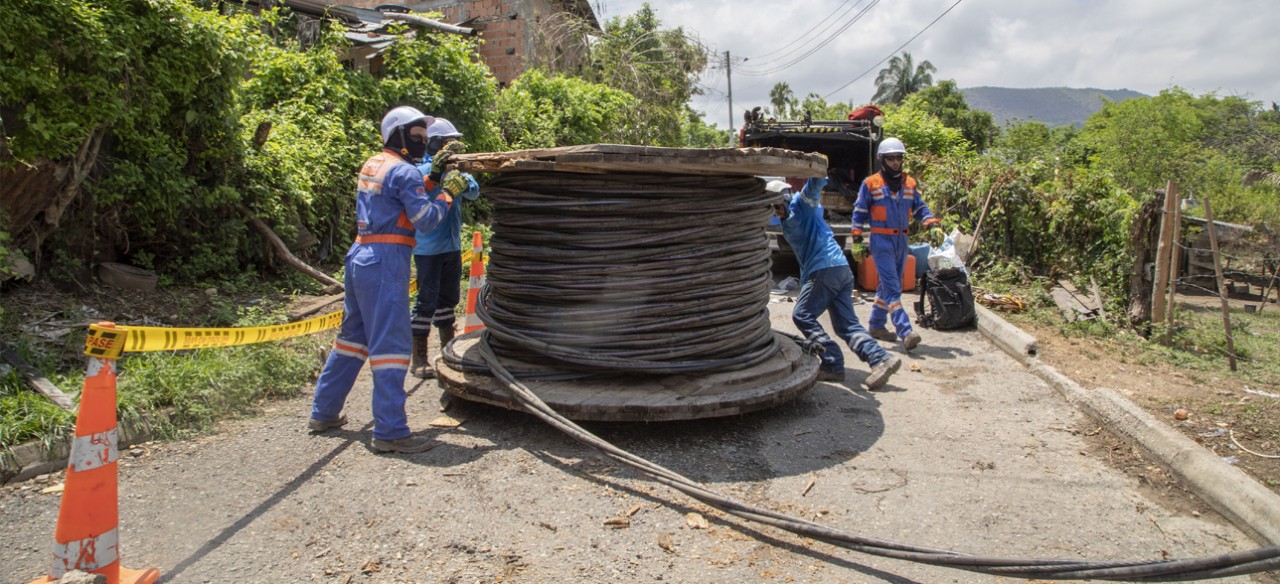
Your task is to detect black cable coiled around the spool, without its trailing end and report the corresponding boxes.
[476,172,778,374]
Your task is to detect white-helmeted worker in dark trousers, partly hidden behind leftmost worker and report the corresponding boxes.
[410,118,480,378]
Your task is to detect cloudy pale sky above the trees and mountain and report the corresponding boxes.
[591,0,1280,127]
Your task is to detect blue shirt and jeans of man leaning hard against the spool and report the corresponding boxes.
[782,178,888,374]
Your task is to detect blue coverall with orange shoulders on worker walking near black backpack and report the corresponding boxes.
[852,173,941,338]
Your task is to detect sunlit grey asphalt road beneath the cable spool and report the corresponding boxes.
[0,266,1256,583]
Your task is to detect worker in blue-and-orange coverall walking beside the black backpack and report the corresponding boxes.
[851,138,943,351]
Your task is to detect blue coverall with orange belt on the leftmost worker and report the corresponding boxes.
[311,150,449,441]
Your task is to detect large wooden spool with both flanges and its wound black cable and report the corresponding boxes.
[438,145,826,420]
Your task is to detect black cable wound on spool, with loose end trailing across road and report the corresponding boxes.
[442,173,1280,581]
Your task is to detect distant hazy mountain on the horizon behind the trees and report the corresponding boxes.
[960,87,1147,128]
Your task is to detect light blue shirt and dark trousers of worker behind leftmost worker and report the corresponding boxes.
[412,157,480,337]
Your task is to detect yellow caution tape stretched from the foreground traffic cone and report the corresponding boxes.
[84,245,489,359]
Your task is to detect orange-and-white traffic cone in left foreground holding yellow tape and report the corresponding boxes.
[32,323,160,584]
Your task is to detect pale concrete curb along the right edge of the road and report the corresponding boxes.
[978,306,1280,546]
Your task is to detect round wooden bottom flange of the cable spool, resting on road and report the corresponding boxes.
[435,330,818,421]
